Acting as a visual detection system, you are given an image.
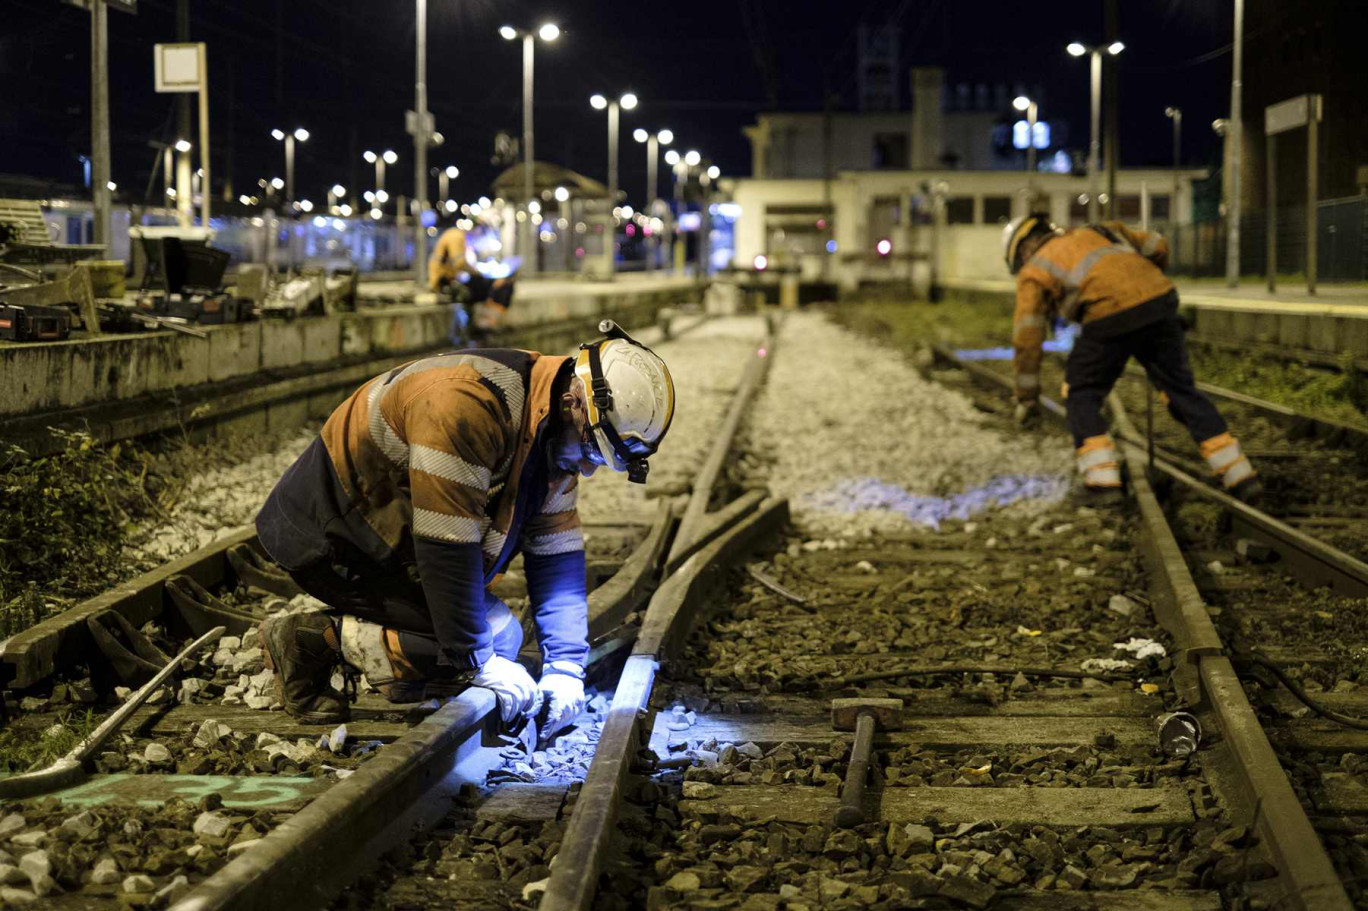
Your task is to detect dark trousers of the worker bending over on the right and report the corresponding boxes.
[1064,315,1226,447]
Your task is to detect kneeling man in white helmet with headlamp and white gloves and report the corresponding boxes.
[256,320,674,732]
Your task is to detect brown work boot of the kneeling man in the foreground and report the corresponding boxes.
[260,613,350,725]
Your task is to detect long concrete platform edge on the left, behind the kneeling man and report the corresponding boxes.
[0,276,705,445]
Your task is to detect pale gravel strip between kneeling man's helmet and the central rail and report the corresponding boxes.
[579,317,765,523]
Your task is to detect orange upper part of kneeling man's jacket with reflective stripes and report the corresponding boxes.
[321,349,584,577]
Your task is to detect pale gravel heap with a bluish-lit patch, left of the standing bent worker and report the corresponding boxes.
[744,313,1073,536]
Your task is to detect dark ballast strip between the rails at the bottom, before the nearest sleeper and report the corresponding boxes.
[610,782,1274,910]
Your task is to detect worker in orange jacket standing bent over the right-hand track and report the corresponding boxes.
[1003,212,1261,501]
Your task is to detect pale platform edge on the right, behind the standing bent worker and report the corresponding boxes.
[944,280,1368,364]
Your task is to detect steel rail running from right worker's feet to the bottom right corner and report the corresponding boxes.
[936,341,1354,911]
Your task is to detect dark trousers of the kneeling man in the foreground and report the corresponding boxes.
[290,541,523,680]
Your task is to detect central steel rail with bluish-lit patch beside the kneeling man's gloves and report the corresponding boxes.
[538,322,788,911]
